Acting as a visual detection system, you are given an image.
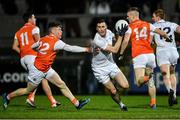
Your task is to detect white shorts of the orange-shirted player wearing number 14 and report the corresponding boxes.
[133,53,156,69]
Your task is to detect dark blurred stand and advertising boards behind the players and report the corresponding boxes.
[0,0,180,94]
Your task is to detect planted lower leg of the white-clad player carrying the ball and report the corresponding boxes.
[103,80,127,111]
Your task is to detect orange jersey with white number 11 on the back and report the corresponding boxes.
[15,23,37,58]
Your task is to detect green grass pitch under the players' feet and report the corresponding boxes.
[0,95,180,119]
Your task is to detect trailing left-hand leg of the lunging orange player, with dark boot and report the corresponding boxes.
[3,82,38,109]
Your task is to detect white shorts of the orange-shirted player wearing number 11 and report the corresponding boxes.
[20,55,36,70]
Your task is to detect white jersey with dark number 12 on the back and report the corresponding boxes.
[154,19,178,49]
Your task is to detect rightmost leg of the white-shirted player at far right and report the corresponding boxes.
[170,65,178,104]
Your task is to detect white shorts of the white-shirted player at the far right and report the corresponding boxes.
[156,49,179,66]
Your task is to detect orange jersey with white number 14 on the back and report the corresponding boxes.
[129,20,154,58]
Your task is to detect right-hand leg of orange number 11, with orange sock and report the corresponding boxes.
[42,79,61,107]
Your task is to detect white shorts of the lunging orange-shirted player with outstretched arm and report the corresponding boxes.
[28,65,55,85]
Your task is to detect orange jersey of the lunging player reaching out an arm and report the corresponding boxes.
[34,35,59,72]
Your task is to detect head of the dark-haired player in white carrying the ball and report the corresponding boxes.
[96,22,107,37]
